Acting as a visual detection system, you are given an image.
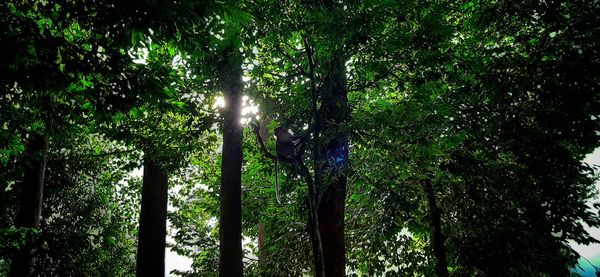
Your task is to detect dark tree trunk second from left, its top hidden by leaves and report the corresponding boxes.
[136,157,169,277]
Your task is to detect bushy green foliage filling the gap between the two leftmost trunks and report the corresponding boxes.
[36,135,141,276]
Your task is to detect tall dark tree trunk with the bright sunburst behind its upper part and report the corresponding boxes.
[219,47,243,277]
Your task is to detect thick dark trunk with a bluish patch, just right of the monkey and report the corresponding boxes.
[318,53,349,277]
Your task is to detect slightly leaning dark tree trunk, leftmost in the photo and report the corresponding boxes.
[8,135,48,277]
